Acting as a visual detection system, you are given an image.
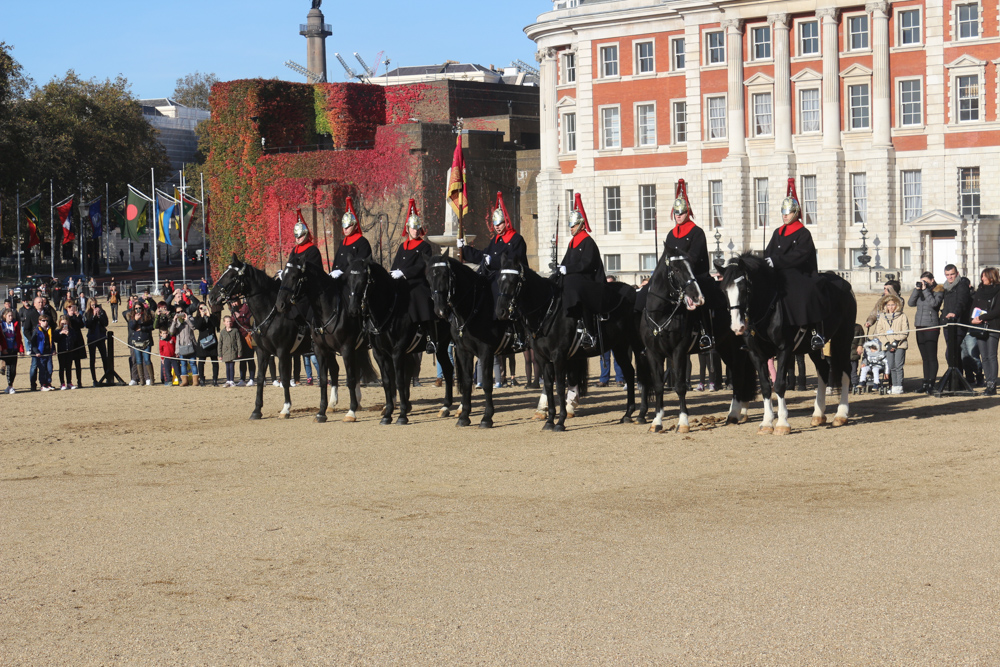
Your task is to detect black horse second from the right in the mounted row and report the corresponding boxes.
[639,251,756,433]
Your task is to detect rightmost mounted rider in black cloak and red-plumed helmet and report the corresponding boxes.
[764,178,829,350]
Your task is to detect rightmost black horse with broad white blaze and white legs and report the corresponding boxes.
[716,253,858,435]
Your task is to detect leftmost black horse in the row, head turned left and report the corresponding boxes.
[208,253,307,419]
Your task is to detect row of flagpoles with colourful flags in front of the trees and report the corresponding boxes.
[6,169,208,293]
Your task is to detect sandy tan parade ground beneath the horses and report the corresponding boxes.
[0,297,1000,665]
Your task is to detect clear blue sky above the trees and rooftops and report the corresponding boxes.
[0,0,552,98]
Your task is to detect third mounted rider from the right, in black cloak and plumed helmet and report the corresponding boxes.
[558,193,607,348]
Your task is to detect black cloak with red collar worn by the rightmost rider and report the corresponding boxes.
[764,223,830,327]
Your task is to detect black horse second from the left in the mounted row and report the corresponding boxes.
[275,259,375,423]
